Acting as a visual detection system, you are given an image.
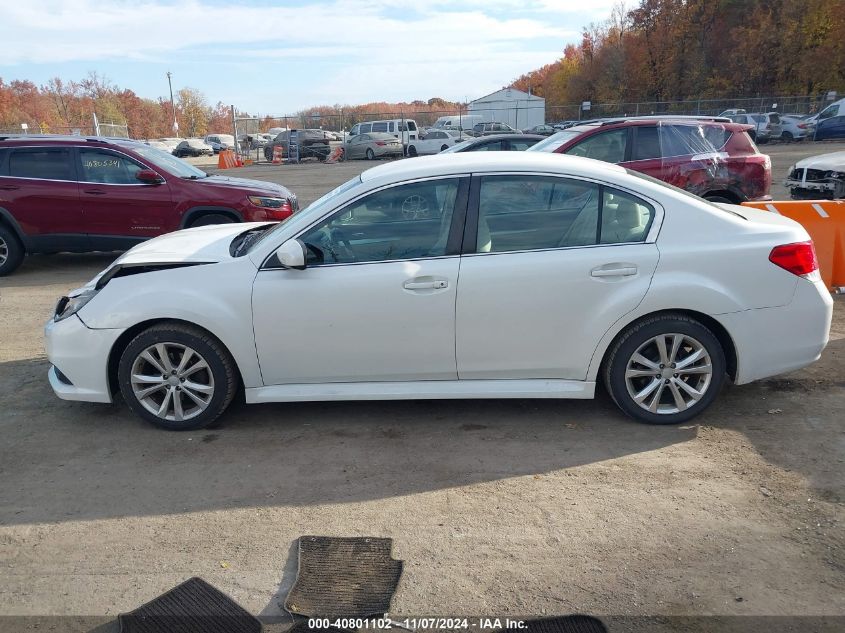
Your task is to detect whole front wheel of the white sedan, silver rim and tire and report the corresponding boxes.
[118,323,237,431]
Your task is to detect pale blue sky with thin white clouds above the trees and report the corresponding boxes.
[0,0,614,115]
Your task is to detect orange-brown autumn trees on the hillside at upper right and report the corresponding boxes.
[513,0,845,107]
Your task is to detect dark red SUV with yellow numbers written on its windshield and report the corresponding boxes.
[0,136,298,276]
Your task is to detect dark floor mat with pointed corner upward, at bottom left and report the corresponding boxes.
[118,578,261,633]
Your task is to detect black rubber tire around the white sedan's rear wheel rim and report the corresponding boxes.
[603,314,725,424]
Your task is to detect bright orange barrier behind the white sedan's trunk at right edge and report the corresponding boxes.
[742,200,845,288]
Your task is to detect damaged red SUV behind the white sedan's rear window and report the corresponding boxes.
[528,117,772,204]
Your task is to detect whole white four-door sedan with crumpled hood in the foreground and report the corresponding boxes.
[46,152,833,430]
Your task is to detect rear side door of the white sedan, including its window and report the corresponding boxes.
[456,175,658,380]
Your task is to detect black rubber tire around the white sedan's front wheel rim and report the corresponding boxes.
[117,322,238,431]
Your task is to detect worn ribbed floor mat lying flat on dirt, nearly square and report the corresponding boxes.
[285,536,402,618]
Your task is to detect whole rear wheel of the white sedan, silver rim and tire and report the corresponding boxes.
[604,315,725,424]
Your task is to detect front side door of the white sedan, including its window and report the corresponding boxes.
[252,177,469,385]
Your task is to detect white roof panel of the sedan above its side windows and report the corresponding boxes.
[361,152,626,183]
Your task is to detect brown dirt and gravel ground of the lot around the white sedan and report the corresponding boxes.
[0,145,845,631]
